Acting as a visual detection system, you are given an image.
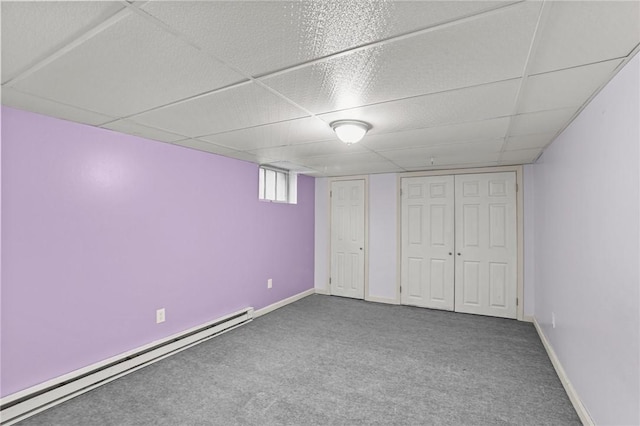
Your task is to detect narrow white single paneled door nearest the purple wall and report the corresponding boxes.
[329,180,365,299]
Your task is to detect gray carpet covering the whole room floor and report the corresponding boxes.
[20,295,580,426]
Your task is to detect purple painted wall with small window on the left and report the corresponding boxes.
[0,107,314,396]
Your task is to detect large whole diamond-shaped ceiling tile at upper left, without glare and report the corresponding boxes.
[15,15,248,117]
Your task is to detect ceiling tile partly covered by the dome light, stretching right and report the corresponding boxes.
[320,80,520,137]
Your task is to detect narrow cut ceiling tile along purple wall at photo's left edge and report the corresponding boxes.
[2,87,114,126]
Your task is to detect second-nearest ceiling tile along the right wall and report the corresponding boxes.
[519,59,622,112]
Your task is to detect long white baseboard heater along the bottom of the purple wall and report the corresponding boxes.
[0,308,253,426]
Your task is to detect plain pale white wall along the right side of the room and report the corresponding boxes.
[532,56,640,425]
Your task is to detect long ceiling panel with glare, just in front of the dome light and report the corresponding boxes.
[262,2,540,114]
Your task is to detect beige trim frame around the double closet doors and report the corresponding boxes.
[396,166,525,321]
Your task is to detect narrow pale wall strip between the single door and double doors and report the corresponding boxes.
[369,173,398,303]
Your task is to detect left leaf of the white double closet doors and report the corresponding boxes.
[400,176,454,311]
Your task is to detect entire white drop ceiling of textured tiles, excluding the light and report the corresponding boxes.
[2,0,640,176]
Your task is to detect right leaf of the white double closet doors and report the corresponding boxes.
[455,172,517,318]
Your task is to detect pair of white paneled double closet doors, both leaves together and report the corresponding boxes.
[400,172,517,318]
